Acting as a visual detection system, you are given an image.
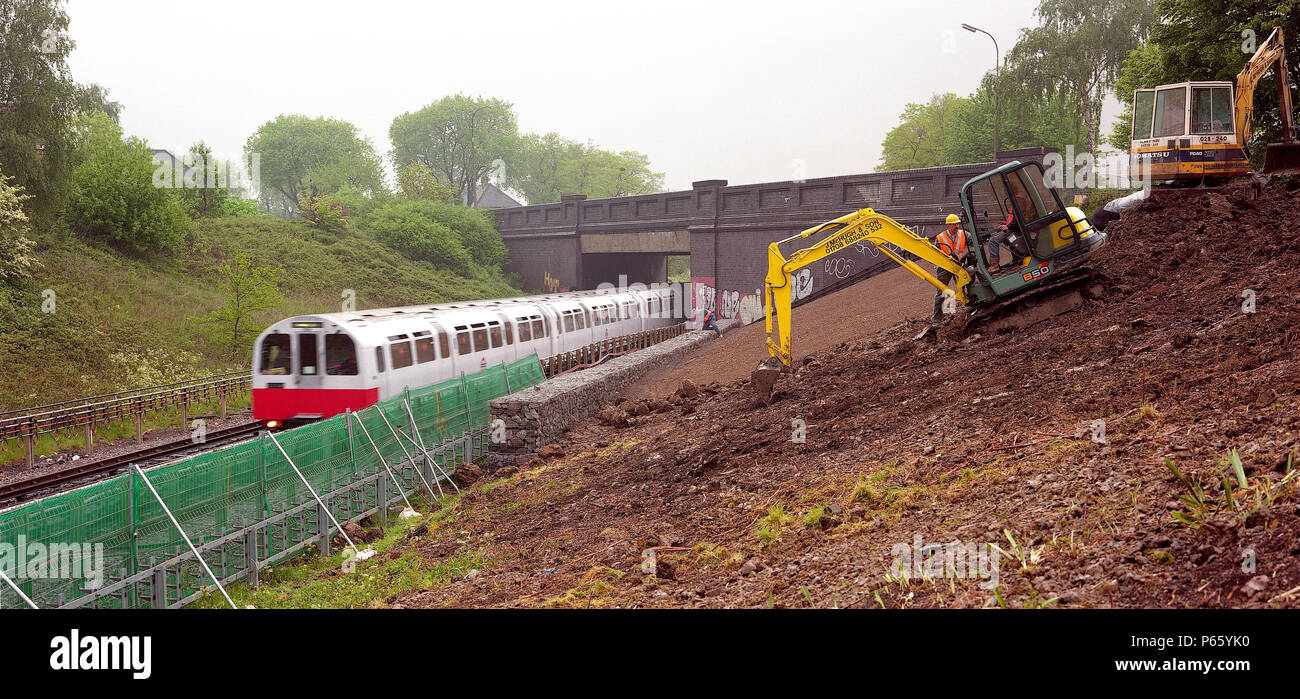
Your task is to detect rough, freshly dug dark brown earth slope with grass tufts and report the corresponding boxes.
[384,183,1300,608]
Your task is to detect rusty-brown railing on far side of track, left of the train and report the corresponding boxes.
[0,370,251,468]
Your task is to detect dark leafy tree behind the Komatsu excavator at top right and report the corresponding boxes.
[1110,0,1300,159]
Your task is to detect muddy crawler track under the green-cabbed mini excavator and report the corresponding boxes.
[962,268,1113,338]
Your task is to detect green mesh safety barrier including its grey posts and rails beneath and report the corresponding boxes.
[0,355,545,608]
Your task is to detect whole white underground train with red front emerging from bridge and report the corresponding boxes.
[252,287,681,427]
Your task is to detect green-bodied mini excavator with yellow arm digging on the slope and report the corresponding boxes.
[750,161,1106,400]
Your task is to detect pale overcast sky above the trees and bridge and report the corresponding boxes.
[69,0,1114,190]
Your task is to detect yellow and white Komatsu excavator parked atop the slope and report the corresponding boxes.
[1128,27,1300,184]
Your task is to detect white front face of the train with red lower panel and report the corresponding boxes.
[252,316,381,427]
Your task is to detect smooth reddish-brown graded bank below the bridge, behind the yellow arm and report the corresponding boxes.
[621,268,935,398]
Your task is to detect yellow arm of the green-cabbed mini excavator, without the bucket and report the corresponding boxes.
[764,209,971,369]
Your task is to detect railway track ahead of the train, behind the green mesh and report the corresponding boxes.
[0,422,263,505]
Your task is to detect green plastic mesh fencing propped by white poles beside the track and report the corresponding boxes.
[0,355,545,608]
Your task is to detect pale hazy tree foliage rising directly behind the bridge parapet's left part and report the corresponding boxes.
[506,133,663,204]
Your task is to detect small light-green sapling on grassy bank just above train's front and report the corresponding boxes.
[200,253,285,352]
